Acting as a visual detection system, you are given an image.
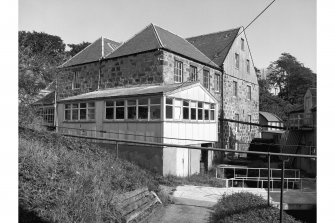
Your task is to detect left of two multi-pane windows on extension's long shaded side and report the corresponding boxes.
[64,102,95,121]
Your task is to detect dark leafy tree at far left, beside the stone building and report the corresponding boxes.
[18,31,67,104]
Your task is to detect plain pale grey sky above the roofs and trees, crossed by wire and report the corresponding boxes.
[19,0,316,72]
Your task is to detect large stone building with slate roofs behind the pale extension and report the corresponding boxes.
[38,24,259,175]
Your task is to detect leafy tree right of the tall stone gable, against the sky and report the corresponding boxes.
[268,53,316,104]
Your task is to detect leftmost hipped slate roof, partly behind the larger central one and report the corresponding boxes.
[61,37,121,67]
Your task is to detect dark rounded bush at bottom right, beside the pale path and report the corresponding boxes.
[210,192,299,223]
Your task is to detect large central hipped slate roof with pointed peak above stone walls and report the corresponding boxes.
[106,24,219,68]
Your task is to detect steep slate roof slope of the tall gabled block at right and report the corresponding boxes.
[186,27,240,66]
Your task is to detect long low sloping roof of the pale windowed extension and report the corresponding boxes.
[60,82,200,102]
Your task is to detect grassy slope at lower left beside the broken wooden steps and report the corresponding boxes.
[19,130,159,222]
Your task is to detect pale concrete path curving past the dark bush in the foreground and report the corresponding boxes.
[149,185,316,223]
